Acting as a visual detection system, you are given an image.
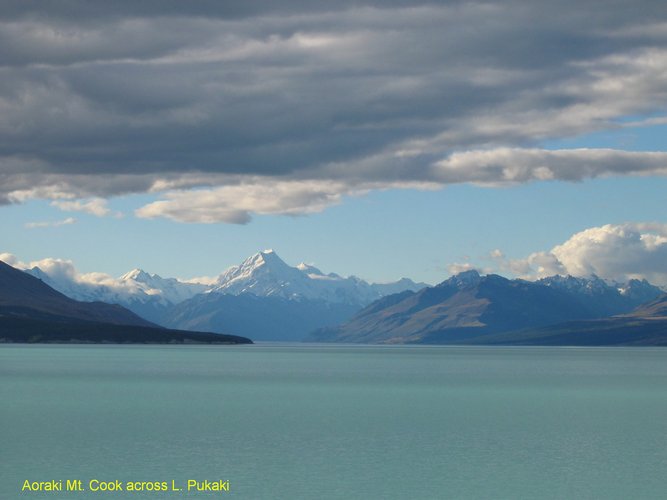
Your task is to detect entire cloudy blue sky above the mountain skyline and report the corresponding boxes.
[0,0,667,286]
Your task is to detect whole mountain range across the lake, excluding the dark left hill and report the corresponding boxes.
[9,250,667,345]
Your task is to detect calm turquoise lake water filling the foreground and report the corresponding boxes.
[0,345,667,500]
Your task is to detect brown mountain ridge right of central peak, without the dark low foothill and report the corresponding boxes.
[310,271,661,344]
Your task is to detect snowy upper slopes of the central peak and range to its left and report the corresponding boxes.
[26,250,426,324]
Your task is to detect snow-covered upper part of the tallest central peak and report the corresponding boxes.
[210,250,426,306]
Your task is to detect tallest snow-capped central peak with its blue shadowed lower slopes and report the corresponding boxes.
[161,250,423,341]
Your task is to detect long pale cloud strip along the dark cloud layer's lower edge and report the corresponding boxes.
[133,148,667,224]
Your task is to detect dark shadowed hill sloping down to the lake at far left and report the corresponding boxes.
[0,261,250,343]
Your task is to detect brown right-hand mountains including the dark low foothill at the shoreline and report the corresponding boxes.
[309,271,667,345]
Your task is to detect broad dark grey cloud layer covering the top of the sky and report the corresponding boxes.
[0,0,667,222]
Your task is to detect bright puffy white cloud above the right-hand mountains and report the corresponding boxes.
[495,223,667,286]
